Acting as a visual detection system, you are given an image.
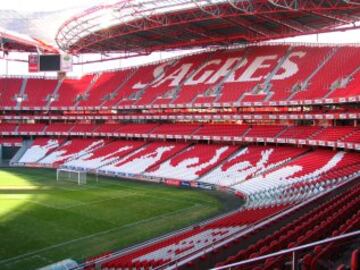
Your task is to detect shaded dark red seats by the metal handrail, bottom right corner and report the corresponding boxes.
[217,182,360,270]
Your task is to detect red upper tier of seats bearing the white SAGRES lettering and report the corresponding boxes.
[0,45,360,109]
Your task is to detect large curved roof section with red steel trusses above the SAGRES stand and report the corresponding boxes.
[56,0,360,53]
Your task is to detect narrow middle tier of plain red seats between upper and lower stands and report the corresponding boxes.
[0,123,360,143]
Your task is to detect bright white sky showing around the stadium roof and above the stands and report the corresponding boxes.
[0,0,360,76]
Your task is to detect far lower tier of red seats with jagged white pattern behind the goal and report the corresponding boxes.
[19,138,360,205]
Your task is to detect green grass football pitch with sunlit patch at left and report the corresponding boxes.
[0,168,239,270]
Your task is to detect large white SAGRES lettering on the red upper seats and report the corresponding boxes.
[133,51,306,89]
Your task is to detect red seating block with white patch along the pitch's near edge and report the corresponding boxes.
[102,205,287,270]
